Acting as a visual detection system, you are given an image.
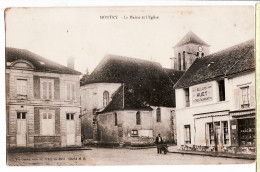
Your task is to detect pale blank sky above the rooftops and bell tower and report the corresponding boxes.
[5,6,255,74]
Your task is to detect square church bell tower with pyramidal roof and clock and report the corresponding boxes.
[171,31,210,70]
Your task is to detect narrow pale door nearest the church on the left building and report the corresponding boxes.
[66,113,75,146]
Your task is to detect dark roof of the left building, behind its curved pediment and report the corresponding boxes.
[5,47,81,75]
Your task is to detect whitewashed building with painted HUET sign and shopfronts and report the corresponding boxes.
[174,40,256,152]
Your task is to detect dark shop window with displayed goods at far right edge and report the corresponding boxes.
[238,118,256,146]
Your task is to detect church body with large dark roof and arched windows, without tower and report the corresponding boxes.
[81,55,183,145]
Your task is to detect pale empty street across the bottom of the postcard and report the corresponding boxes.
[7,148,254,166]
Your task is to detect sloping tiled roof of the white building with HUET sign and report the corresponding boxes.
[174,40,255,88]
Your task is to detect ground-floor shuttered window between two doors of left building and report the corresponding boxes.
[40,111,55,136]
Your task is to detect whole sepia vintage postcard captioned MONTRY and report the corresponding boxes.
[5,5,257,166]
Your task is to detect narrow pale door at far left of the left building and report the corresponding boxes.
[16,112,26,146]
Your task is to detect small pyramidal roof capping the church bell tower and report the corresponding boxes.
[174,31,209,47]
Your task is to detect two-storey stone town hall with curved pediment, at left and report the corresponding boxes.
[6,48,81,147]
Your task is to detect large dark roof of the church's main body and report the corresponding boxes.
[82,55,183,113]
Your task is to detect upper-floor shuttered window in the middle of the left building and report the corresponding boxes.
[41,79,54,100]
